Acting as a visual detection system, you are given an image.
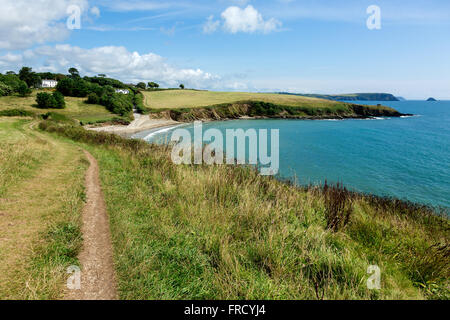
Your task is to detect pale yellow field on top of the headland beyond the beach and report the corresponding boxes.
[143,90,341,109]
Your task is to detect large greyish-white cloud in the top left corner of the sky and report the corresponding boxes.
[0,0,88,50]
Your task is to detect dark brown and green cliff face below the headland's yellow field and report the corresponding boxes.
[149,101,410,122]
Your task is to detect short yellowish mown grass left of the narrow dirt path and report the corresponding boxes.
[0,117,87,299]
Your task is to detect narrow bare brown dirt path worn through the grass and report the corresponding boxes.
[65,151,117,300]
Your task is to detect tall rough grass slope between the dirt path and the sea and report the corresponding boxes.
[40,122,449,299]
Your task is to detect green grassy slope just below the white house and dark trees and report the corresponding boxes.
[0,90,117,122]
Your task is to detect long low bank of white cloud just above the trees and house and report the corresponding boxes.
[0,44,220,88]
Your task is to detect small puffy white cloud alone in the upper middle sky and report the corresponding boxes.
[222,5,281,33]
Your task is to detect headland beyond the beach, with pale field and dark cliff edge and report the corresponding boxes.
[144,90,400,122]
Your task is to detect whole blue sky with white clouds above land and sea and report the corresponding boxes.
[0,0,450,99]
